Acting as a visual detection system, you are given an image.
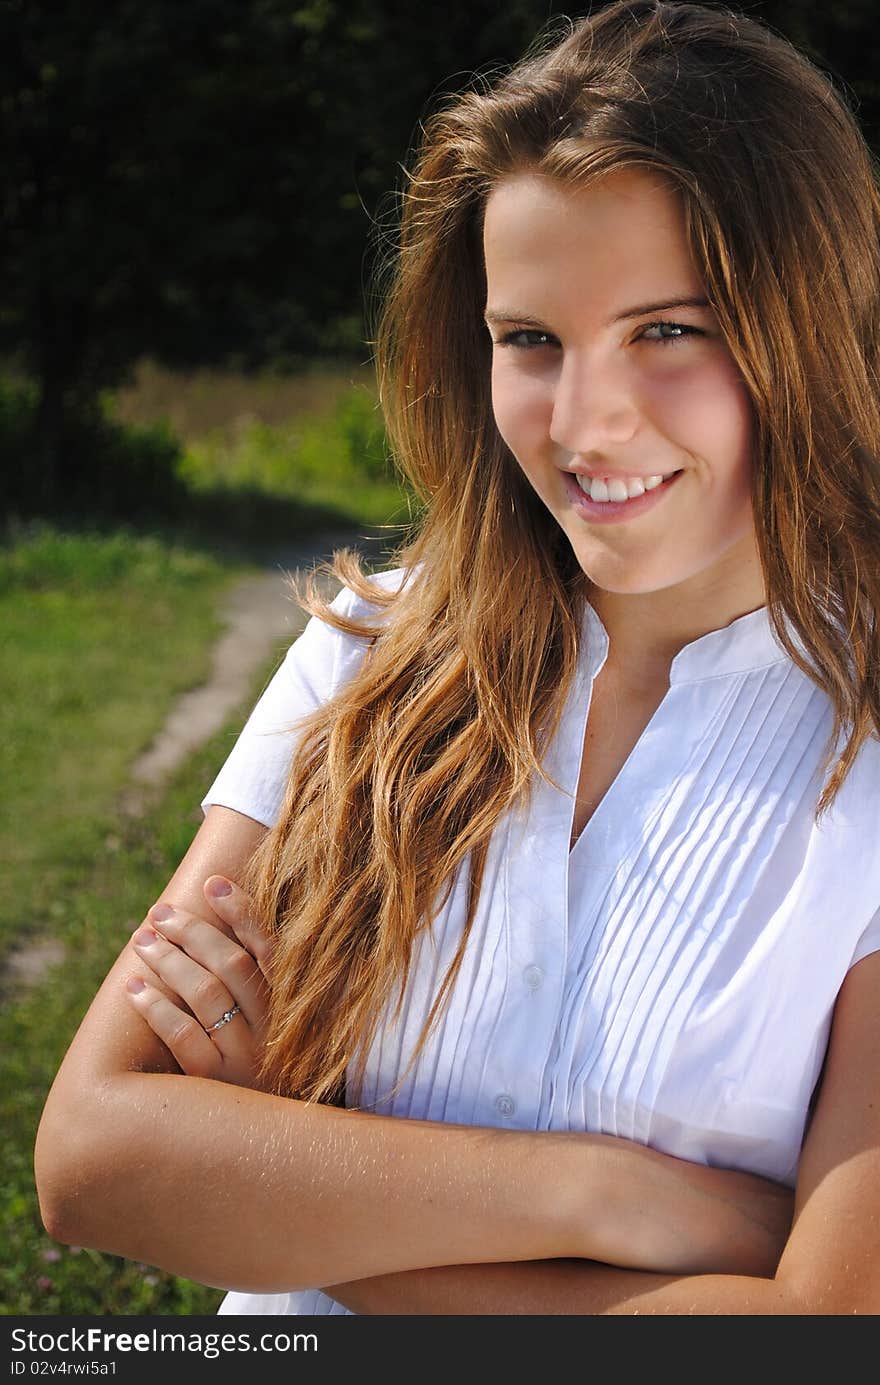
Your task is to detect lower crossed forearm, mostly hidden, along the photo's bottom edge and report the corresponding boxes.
[326,1259,815,1317]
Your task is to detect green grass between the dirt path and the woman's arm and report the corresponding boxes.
[0,709,267,1314]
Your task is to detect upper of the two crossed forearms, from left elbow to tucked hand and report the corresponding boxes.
[36,1047,790,1292]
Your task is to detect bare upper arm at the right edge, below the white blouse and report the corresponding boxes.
[777,951,880,1314]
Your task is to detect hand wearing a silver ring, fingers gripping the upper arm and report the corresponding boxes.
[126,875,272,1087]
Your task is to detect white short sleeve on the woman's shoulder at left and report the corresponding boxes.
[201,569,399,827]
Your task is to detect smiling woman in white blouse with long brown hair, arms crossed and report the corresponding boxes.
[36,3,880,1314]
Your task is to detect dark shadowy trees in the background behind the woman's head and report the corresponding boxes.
[0,0,874,509]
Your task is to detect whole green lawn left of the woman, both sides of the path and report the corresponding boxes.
[0,526,257,1313]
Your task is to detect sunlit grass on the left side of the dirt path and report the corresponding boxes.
[0,526,247,956]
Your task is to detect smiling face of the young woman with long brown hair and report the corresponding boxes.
[484,169,762,601]
